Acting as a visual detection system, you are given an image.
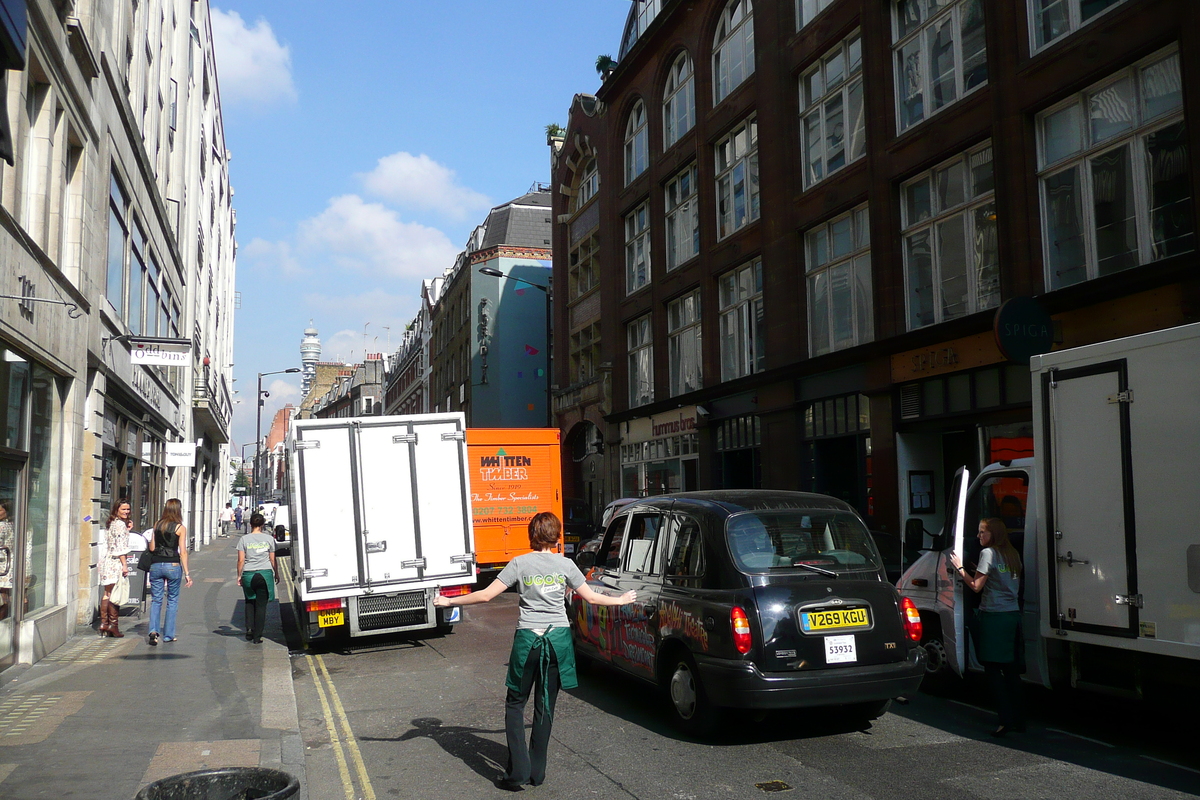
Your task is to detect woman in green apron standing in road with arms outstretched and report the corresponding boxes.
[433,511,637,792]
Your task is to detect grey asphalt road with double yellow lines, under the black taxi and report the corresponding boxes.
[283,594,1200,800]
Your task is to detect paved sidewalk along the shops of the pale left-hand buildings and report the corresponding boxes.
[0,536,308,800]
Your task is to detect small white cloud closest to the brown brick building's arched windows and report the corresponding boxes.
[358,151,492,219]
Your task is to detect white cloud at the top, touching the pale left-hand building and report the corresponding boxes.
[212,8,296,108]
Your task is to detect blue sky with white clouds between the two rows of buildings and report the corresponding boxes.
[212,0,630,445]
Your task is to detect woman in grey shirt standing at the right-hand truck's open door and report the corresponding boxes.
[950,517,1025,736]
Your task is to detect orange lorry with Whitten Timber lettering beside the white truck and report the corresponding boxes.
[467,428,563,572]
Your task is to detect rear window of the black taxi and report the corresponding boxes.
[725,509,882,572]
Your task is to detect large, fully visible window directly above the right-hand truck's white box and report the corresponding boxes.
[1037,48,1195,289]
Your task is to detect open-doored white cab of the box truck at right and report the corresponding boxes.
[898,458,1049,685]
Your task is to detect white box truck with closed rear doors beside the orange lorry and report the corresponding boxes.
[287,414,475,642]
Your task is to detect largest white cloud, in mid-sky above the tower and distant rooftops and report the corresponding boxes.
[299,194,458,278]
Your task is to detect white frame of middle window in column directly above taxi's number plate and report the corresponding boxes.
[797,29,866,188]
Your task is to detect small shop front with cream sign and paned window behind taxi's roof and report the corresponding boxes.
[620,405,700,498]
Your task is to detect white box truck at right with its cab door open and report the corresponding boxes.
[899,324,1200,696]
